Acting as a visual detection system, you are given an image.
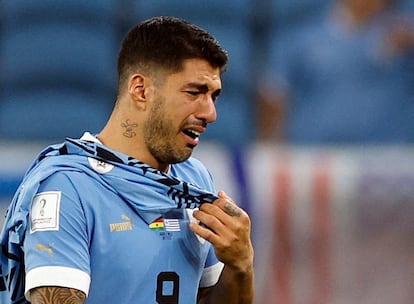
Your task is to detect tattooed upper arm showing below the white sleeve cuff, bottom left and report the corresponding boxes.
[30,287,86,304]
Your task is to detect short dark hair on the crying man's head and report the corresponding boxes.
[118,16,228,84]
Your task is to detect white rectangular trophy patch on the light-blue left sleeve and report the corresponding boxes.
[30,191,61,233]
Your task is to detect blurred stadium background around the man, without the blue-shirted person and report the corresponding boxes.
[0,0,414,304]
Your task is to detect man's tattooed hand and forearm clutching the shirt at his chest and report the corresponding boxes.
[190,191,254,304]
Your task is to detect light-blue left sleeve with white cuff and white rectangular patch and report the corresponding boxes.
[24,172,90,297]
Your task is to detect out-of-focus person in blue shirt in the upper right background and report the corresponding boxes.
[257,0,414,145]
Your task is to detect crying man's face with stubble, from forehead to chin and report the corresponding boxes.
[144,59,221,164]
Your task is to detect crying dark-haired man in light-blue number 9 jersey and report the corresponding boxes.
[0,17,253,304]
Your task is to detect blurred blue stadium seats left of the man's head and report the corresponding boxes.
[0,0,118,140]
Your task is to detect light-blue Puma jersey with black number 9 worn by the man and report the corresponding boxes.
[0,134,223,303]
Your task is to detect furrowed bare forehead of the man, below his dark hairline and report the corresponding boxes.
[167,59,221,90]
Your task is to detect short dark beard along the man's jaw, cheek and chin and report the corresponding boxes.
[144,96,192,164]
